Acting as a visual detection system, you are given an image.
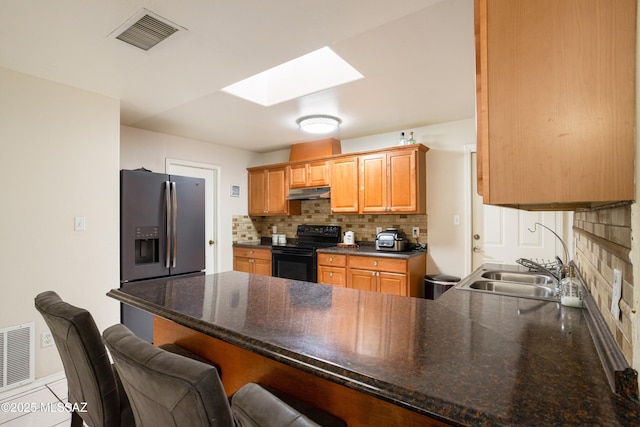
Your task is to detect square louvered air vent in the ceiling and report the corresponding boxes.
[111,9,184,50]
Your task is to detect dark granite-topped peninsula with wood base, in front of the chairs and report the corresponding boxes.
[108,272,640,426]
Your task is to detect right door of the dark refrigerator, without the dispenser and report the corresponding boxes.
[170,175,205,276]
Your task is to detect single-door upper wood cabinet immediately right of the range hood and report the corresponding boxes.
[331,156,359,213]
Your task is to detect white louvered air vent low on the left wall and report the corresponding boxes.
[0,323,35,391]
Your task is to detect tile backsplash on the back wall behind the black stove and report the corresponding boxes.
[232,199,427,243]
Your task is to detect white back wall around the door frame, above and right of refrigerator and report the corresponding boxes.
[120,126,263,272]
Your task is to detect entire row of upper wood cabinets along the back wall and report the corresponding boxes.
[247,144,429,216]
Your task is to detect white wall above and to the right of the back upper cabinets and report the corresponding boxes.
[264,118,476,277]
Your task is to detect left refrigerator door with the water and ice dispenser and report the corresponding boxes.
[120,170,170,282]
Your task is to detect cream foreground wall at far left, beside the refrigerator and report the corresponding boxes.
[0,69,120,378]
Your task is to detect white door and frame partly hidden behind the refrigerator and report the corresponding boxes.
[165,159,218,274]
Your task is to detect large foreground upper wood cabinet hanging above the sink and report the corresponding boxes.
[475,0,636,209]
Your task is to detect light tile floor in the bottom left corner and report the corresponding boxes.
[0,379,84,427]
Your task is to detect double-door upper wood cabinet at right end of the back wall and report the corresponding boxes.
[359,145,426,213]
